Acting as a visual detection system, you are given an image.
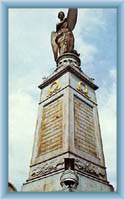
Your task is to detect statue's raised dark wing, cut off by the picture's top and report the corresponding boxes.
[67,8,78,31]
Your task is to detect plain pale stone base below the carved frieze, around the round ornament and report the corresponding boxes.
[22,172,113,192]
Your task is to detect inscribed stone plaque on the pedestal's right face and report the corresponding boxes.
[74,96,97,156]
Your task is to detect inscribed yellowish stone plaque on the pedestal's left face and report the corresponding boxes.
[38,97,63,156]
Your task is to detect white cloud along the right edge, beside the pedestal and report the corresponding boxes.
[98,69,117,189]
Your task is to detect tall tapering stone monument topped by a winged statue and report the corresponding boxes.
[22,9,114,192]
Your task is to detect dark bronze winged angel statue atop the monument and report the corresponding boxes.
[51,8,78,61]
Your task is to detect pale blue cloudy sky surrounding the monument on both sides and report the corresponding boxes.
[9,8,117,190]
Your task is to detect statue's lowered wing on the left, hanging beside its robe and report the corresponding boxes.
[51,31,58,60]
